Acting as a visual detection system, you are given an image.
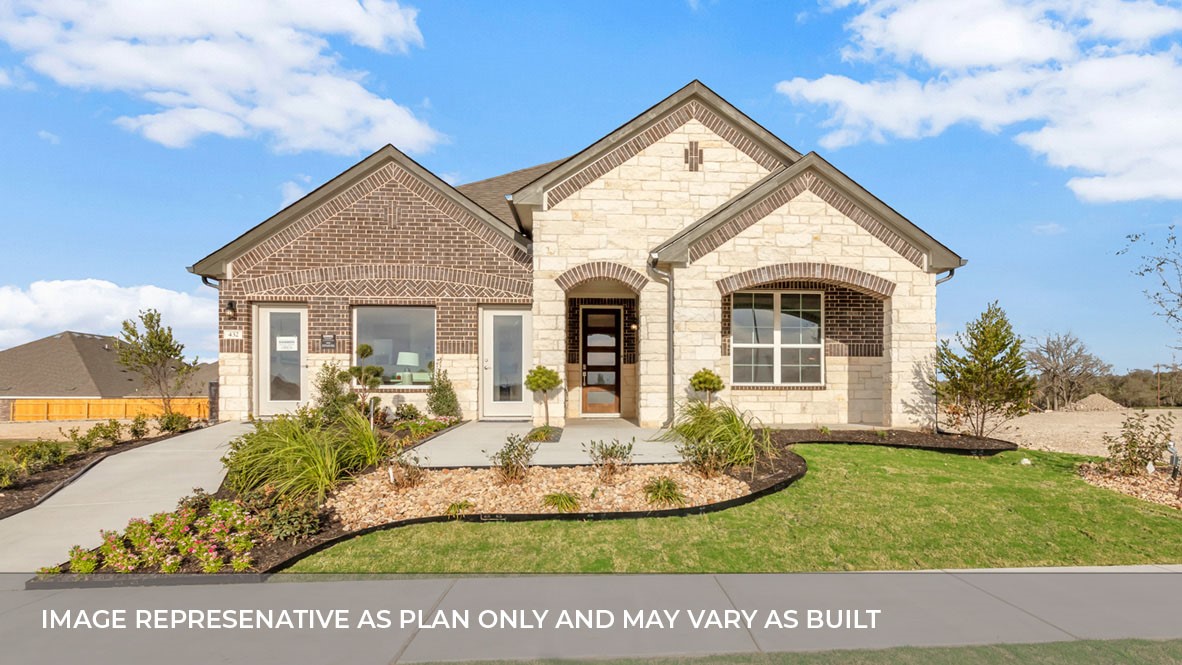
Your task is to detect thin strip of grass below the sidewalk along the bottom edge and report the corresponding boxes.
[416,640,1182,665]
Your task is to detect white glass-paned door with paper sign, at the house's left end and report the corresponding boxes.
[255,306,307,416]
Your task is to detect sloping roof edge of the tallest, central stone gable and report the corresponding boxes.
[512,79,800,213]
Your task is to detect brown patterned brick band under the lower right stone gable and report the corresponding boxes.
[689,171,923,268]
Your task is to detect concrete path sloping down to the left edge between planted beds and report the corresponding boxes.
[0,423,251,573]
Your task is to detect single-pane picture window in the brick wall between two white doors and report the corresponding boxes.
[353,307,435,386]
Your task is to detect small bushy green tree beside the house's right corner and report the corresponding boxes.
[933,301,1034,436]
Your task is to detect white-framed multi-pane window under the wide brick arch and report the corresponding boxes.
[730,291,825,385]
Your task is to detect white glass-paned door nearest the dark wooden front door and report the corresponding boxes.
[480,307,533,418]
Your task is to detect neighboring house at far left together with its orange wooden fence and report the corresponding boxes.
[0,331,217,422]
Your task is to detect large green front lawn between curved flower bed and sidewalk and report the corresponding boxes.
[293,444,1182,573]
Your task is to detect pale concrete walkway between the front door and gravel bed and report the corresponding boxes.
[415,418,681,468]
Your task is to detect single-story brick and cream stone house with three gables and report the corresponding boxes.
[189,80,965,426]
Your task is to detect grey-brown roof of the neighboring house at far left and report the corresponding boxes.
[0,331,217,399]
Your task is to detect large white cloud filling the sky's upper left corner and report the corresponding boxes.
[0,0,442,155]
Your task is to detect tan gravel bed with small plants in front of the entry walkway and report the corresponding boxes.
[329,464,751,530]
